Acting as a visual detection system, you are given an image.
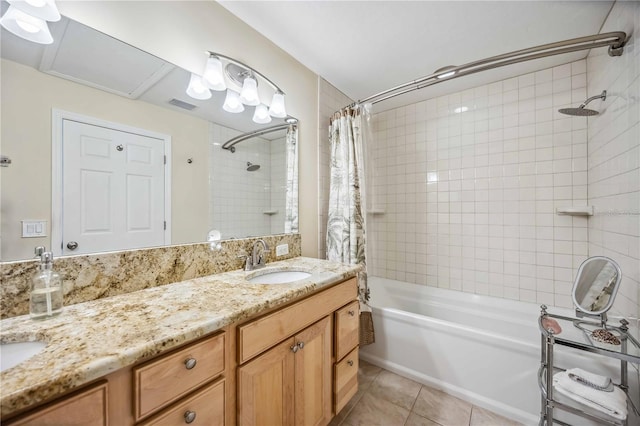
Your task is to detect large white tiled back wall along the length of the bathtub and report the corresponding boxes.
[368,60,588,307]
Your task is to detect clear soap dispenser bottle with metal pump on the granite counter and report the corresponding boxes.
[29,251,62,319]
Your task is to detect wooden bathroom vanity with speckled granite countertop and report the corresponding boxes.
[0,258,359,426]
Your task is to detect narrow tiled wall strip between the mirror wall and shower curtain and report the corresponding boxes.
[318,77,353,259]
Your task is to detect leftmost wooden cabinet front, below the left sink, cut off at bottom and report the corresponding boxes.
[3,382,108,426]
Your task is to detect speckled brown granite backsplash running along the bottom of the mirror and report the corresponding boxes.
[0,234,301,319]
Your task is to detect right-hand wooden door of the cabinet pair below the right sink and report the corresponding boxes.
[295,317,333,426]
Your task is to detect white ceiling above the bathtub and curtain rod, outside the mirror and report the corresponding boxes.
[220,1,613,111]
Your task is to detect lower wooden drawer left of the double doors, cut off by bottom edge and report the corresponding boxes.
[143,380,225,426]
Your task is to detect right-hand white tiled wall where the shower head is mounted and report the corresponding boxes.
[587,2,640,318]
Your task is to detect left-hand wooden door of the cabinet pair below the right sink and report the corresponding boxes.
[238,338,295,426]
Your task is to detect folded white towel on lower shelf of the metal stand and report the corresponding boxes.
[553,371,627,420]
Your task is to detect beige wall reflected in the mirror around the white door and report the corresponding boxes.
[0,60,209,261]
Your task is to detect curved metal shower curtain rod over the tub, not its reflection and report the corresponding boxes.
[348,31,627,108]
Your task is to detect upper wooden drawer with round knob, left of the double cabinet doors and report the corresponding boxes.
[133,333,225,420]
